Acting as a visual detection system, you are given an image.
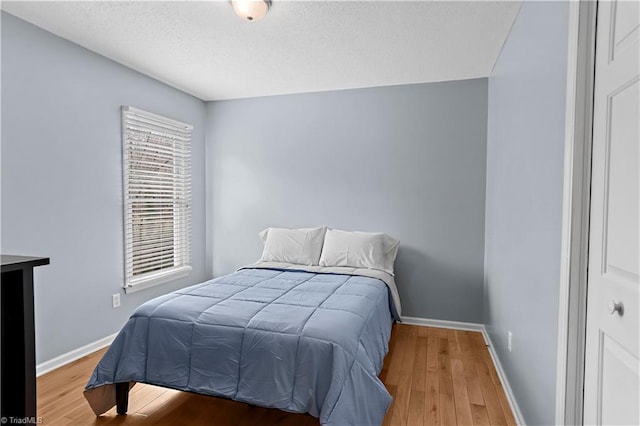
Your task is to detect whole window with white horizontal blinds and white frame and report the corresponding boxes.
[122,107,193,292]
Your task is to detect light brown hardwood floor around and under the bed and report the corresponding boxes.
[37,324,516,426]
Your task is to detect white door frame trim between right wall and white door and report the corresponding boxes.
[556,0,597,425]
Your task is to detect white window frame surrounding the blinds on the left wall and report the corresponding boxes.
[121,106,193,293]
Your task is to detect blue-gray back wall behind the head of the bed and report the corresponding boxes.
[206,79,487,322]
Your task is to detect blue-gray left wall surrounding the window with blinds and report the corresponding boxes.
[1,12,209,362]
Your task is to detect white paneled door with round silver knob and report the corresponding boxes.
[584,0,640,425]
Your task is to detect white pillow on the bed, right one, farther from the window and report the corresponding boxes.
[320,229,400,275]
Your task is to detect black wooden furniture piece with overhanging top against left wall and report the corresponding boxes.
[0,255,49,419]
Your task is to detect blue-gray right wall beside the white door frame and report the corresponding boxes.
[484,1,569,424]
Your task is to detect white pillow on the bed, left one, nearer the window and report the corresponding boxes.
[259,227,327,265]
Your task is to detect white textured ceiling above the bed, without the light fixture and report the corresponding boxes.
[2,0,520,100]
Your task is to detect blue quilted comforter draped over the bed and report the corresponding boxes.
[85,269,393,426]
